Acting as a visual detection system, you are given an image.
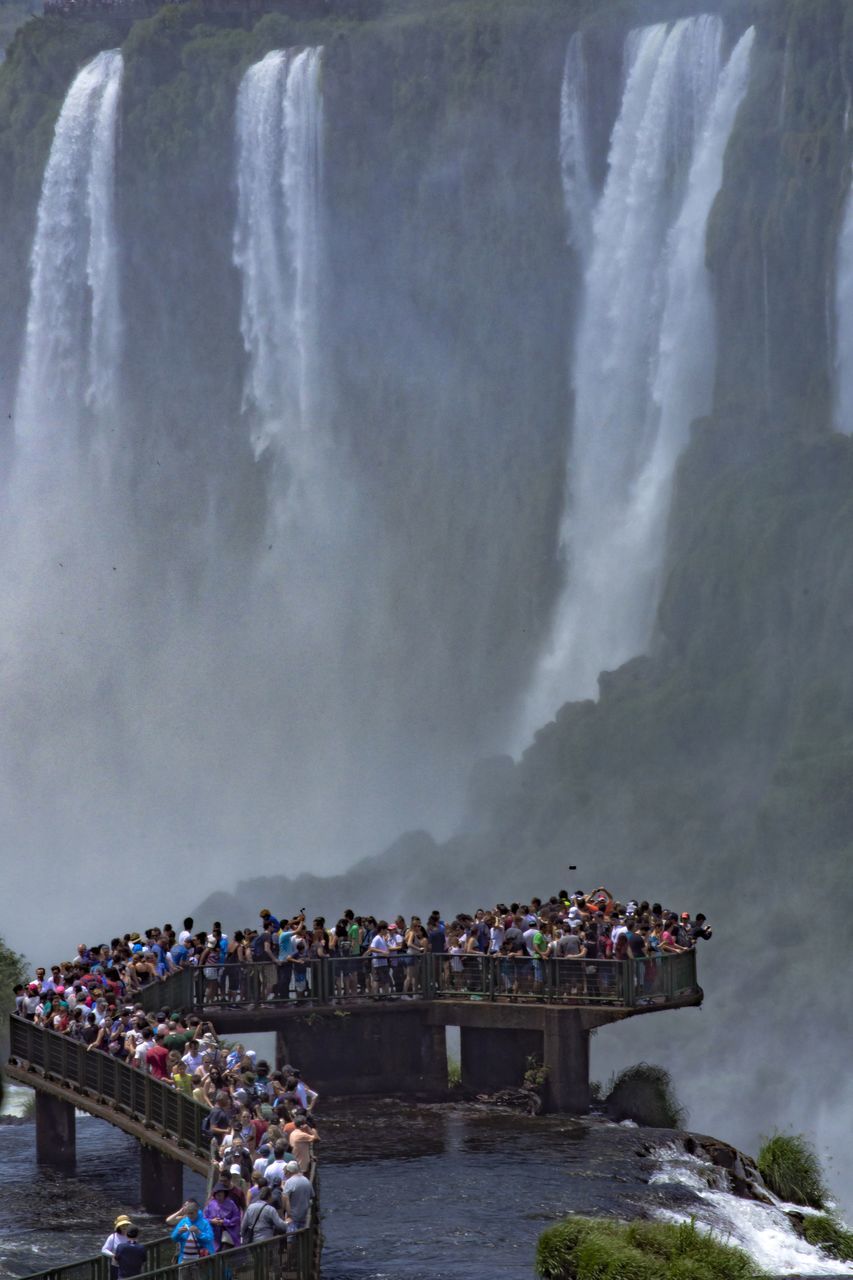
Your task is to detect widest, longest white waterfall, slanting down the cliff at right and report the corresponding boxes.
[524,15,753,733]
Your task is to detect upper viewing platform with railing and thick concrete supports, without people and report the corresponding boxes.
[134,951,703,1114]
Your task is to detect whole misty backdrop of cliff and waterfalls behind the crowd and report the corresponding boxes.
[0,0,853,1228]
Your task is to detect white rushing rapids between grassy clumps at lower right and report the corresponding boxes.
[649,1143,853,1276]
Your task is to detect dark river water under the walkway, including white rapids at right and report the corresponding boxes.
[0,1089,853,1280]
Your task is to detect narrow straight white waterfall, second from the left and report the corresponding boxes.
[234,49,323,475]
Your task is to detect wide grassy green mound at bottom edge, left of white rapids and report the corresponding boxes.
[537,1217,763,1280]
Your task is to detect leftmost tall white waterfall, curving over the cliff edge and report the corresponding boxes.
[14,50,123,448]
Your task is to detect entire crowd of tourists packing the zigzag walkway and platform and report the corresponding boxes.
[9,886,712,1280]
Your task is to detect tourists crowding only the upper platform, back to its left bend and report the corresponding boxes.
[15,886,711,1024]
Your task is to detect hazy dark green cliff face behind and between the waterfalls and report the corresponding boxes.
[0,0,853,1198]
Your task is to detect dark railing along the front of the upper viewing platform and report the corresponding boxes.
[131,951,698,1012]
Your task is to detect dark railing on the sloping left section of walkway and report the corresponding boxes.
[9,1015,209,1158]
